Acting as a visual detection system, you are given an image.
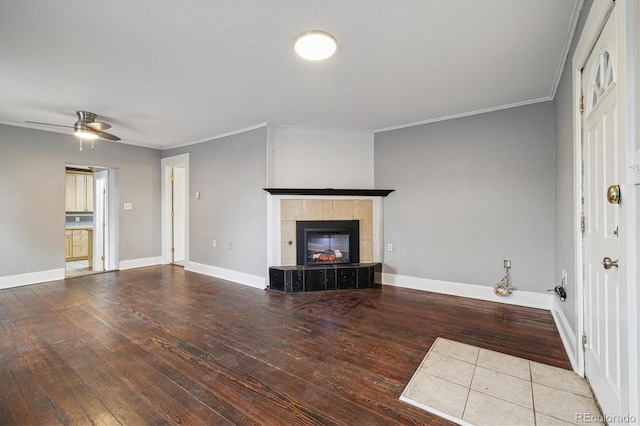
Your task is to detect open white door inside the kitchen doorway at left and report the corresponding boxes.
[93,170,109,271]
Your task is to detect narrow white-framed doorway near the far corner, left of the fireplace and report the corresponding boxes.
[161,153,189,266]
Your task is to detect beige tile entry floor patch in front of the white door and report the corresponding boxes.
[400,337,602,426]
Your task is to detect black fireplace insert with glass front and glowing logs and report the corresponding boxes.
[296,220,360,266]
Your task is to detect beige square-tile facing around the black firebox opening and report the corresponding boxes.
[280,199,374,266]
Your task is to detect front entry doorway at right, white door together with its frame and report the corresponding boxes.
[574,2,638,423]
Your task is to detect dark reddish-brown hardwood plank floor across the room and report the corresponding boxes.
[0,266,570,425]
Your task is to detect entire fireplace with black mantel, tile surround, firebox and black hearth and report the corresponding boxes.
[267,193,391,293]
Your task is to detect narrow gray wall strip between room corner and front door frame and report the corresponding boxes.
[554,0,592,333]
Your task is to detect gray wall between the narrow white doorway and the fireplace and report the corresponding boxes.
[162,126,267,277]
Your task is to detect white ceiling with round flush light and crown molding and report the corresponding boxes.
[0,0,581,148]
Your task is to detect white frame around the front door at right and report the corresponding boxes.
[571,0,640,422]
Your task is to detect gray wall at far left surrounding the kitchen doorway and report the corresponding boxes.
[0,125,161,277]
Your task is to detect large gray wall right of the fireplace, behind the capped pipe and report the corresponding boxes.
[375,102,555,292]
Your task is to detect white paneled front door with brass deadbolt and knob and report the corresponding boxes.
[582,7,629,416]
